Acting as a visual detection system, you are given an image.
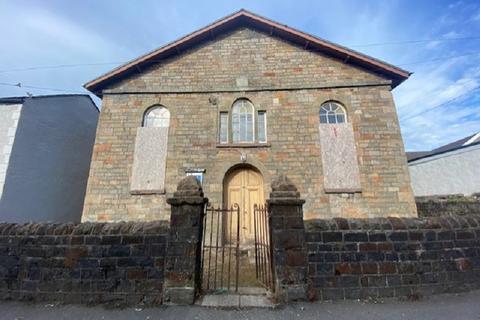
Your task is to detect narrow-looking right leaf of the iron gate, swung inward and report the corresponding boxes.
[253,205,274,292]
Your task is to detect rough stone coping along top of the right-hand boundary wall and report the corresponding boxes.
[305,215,480,232]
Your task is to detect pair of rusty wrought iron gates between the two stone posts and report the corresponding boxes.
[200,204,273,294]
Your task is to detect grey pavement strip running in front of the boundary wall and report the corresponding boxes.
[0,290,480,320]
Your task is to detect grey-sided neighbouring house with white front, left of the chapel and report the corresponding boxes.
[0,95,98,222]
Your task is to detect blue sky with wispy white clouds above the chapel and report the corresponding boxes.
[0,0,480,151]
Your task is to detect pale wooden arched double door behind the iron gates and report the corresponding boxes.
[224,168,265,246]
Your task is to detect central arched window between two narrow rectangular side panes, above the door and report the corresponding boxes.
[232,99,255,143]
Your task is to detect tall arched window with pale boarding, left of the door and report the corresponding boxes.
[130,107,170,193]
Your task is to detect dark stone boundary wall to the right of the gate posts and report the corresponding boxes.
[306,215,480,300]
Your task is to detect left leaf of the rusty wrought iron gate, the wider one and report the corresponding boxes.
[201,204,240,293]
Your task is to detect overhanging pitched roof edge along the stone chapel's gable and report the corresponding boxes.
[84,9,411,95]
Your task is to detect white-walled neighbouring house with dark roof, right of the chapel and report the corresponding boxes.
[407,132,480,196]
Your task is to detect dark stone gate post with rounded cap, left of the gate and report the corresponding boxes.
[163,176,208,304]
